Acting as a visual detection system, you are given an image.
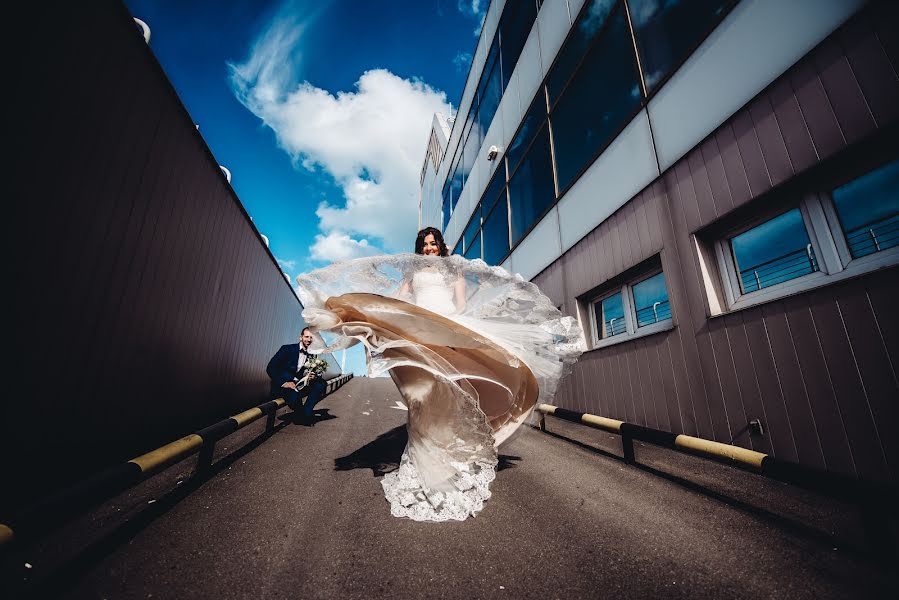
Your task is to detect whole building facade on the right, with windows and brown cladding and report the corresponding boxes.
[420,0,899,481]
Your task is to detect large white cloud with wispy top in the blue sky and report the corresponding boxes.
[229,5,452,261]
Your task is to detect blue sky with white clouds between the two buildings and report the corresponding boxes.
[126,0,488,370]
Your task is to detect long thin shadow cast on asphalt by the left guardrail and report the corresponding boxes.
[0,417,287,598]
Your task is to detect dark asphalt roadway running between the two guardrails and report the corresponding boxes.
[6,378,899,600]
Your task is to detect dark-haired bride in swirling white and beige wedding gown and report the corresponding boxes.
[297,227,582,521]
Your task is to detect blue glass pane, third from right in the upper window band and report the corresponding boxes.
[509,127,556,243]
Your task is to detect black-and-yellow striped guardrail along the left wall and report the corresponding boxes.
[0,373,353,551]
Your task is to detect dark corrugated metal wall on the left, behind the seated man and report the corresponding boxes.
[0,2,302,506]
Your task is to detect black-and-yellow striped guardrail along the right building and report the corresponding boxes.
[536,404,899,554]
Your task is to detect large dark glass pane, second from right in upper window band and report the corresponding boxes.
[550,4,641,190]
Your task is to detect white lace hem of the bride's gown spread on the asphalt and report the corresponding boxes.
[381,451,496,522]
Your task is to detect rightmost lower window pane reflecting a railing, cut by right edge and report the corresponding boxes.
[831,161,899,258]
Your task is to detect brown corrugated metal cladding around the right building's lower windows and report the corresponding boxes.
[535,5,899,481]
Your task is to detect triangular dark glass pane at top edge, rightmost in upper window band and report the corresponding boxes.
[627,0,736,91]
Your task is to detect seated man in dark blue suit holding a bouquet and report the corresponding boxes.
[265,327,327,427]
